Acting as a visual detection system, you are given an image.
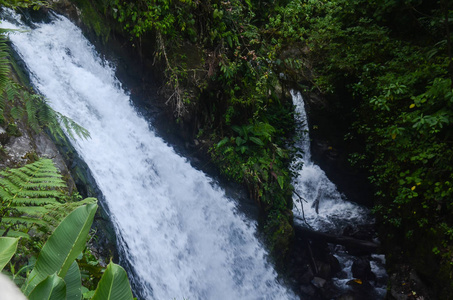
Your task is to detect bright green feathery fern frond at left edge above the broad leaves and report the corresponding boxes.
[0,159,77,236]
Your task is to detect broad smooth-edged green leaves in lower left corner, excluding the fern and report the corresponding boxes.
[0,204,133,300]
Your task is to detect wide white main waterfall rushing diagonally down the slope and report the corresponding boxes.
[1,12,295,300]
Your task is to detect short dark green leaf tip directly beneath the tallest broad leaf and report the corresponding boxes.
[28,274,66,300]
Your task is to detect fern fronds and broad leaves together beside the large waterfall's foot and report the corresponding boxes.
[0,159,132,300]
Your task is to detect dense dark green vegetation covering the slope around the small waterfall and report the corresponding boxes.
[89,0,453,297]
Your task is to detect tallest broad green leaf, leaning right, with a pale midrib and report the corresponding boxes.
[24,204,97,295]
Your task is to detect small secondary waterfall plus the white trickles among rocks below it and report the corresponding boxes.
[291,91,387,299]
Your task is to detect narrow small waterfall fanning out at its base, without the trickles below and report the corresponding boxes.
[291,91,370,233]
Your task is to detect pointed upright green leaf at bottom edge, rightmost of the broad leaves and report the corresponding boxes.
[91,262,133,300]
